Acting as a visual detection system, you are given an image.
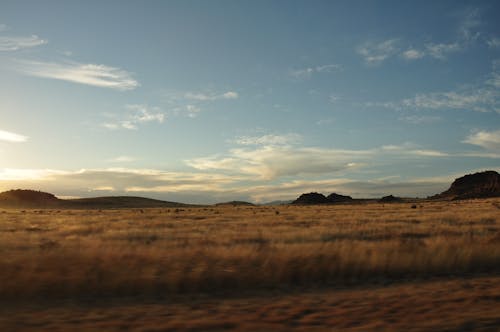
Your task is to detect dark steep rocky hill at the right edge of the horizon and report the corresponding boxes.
[431,171,500,200]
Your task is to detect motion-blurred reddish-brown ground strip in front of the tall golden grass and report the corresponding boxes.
[0,277,500,332]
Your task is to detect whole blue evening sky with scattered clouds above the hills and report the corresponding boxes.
[0,0,500,203]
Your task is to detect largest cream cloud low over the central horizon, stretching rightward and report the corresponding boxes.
[186,141,448,180]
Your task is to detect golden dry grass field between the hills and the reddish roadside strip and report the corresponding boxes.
[0,199,500,299]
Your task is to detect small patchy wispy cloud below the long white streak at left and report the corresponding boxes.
[102,104,166,130]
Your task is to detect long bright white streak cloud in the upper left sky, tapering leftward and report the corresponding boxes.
[16,61,139,91]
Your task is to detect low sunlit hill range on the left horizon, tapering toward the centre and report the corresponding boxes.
[0,189,190,209]
